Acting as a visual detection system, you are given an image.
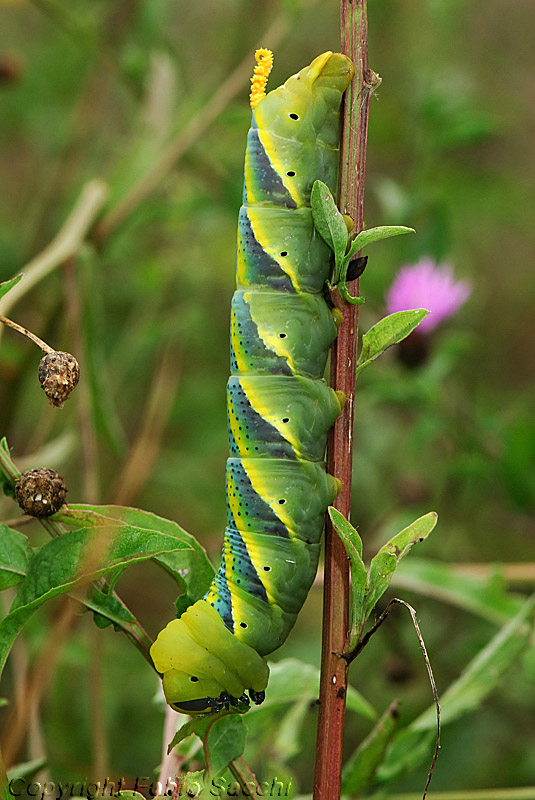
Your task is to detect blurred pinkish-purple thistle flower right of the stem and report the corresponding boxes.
[386,258,472,333]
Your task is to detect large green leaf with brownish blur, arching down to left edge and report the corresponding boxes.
[0,507,211,671]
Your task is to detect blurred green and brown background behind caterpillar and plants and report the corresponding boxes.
[0,0,535,792]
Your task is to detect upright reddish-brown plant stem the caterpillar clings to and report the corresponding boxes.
[314,0,377,800]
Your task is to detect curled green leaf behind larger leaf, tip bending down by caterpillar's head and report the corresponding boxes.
[52,504,214,600]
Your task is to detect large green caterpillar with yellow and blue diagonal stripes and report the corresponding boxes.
[151,50,353,714]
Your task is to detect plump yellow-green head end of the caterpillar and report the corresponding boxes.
[150,600,269,715]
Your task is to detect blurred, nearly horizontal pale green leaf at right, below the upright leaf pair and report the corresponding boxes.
[392,558,524,625]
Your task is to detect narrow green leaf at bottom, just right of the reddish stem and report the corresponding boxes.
[342,703,399,795]
